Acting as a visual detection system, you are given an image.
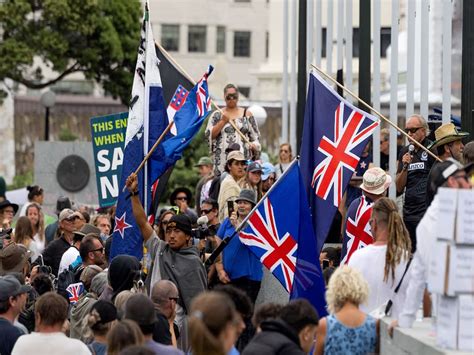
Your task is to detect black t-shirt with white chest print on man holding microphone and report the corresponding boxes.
[397,138,435,221]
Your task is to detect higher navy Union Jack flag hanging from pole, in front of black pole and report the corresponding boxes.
[300,73,379,250]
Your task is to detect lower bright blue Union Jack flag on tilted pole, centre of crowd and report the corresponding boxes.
[239,161,326,316]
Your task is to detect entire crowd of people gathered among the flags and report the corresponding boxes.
[0,84,474,355]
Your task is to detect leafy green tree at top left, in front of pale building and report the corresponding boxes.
[0,0,142,105]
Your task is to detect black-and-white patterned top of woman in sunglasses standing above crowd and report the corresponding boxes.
[205,109,261,175]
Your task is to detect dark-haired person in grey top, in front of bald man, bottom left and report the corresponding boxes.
[125,293,183,355]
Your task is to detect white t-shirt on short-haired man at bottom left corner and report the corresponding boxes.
[12,332,91,355]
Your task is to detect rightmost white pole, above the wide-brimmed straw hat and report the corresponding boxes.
[443,0,452,123]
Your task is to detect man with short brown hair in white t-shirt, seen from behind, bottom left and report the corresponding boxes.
[12,292,90,355]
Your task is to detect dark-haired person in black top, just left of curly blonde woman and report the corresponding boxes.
[242,299,319,355]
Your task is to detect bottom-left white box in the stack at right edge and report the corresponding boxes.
[436,296,459,349]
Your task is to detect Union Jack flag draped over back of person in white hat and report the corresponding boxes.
[341,196,374,264]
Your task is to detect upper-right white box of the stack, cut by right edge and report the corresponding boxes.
[456,189,474,244]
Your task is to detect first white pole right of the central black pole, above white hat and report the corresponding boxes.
[389,0,399,199]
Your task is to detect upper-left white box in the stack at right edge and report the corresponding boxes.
[436,187,457,240]
